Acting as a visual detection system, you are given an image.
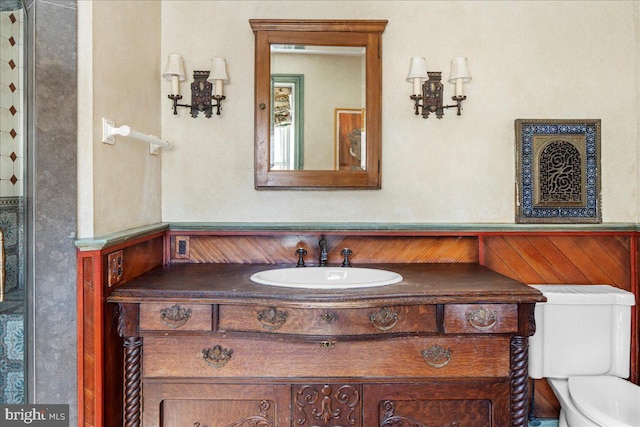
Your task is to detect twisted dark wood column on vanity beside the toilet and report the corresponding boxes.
[511,336,529,427]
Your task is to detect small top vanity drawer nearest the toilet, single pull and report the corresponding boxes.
[444,304,518,334]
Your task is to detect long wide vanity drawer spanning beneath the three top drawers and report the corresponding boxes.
[143,336,510,380]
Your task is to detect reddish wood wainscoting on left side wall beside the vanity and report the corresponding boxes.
[77,232,164,427]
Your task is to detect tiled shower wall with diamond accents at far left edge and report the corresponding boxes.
[0,10,25,403]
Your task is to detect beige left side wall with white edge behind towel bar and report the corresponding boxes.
[78,0,166,238]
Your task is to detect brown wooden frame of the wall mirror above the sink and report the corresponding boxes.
[249,19,387,190]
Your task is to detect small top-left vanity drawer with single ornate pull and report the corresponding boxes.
[140,303,211,331]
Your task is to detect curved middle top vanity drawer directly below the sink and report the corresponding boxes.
[219,305,437,336]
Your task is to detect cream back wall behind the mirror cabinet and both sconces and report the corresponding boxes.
[162,1,639,223]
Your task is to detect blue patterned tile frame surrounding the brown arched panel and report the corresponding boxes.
[515,119,602,224]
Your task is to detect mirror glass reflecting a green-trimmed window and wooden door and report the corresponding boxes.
[269,44,367,171]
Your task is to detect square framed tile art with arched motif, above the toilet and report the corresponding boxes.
[515,119,602,224]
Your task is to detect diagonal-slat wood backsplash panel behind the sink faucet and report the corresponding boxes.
[170,233,478,266]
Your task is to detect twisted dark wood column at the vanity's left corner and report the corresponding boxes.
[124,337,142,427]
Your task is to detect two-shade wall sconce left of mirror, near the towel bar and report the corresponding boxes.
[162,54,229,118]
